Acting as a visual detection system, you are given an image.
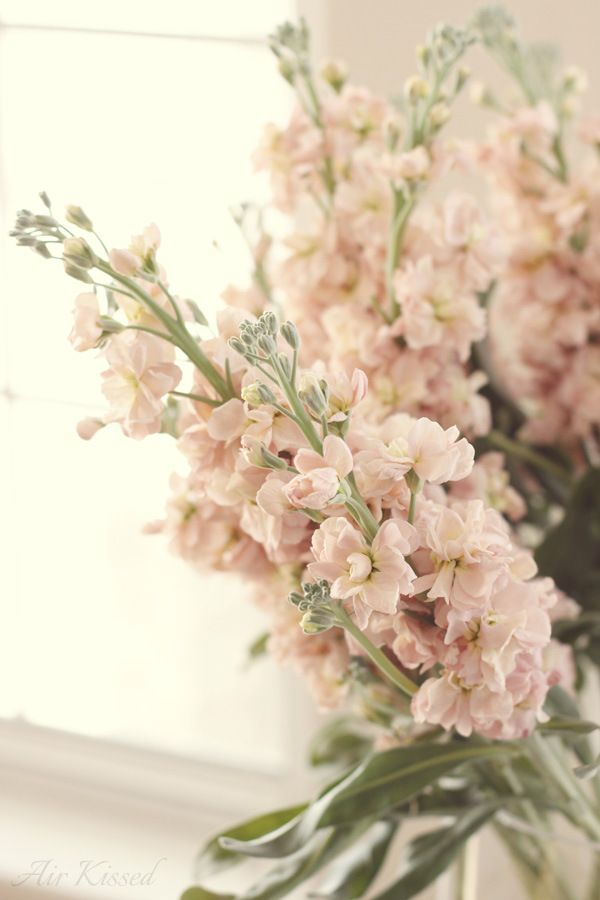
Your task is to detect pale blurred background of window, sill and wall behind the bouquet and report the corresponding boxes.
[0,0,600,900]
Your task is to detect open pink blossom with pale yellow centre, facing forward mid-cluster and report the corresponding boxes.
[308,517,416,628]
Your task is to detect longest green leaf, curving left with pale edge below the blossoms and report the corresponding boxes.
[221,742,515,857]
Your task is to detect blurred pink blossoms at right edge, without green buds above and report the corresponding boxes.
[482,101,600,443]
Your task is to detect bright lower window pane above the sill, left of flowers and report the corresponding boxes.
[0,402,286,768]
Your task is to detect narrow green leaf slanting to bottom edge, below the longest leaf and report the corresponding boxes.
[374,803,500,900]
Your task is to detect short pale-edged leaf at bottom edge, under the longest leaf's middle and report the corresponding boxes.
[309,821,398,900]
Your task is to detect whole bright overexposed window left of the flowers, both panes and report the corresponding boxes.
[0,0,300,769]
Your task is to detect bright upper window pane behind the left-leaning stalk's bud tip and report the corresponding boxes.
[0,30,289,403]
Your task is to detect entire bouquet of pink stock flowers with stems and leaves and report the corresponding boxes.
[12,9,600,900]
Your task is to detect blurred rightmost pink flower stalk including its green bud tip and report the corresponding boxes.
[477,7,600,449]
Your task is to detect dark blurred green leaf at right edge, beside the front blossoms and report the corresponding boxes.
[535,468,600,610]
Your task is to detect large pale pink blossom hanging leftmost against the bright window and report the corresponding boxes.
[102,332,181,438]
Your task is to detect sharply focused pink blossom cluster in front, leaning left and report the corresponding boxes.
[55,214,569,738]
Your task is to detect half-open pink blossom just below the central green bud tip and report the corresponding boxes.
[284,434,353,509]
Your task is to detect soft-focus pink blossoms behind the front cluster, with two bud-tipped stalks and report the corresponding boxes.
[226,22,502,435]
